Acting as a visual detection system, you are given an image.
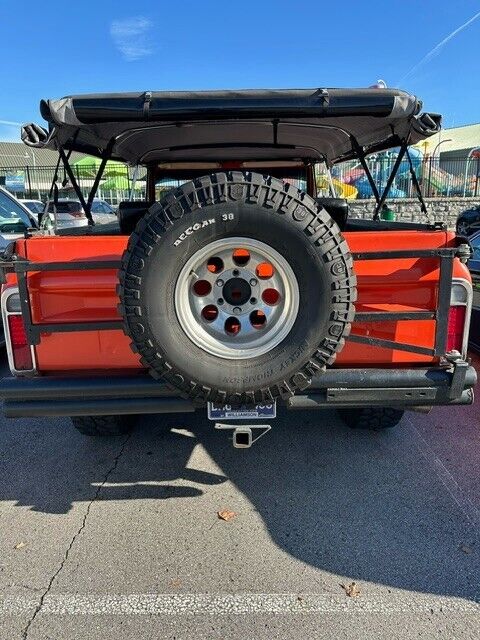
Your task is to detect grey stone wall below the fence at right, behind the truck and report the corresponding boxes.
[349,198,480,229]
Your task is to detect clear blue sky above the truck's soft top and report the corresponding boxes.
[0,0,480,140]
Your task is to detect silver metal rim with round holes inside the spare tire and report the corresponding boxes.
[175,237,300,360]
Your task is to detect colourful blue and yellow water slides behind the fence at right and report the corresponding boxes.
[317,147,470,199]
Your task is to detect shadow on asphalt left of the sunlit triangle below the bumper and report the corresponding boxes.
[0,417,226,514]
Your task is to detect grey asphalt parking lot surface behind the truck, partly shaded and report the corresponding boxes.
[0,359,480,640]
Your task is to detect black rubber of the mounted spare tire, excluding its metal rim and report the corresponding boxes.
[118,171,356,405]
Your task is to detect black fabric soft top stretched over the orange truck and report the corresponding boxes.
[22,88,441,164]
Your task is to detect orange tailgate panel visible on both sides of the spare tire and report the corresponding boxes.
[9,231,470,372]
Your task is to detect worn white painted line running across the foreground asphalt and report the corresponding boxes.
[0,593,480,616]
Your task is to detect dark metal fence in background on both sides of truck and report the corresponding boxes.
[0,156,480,205]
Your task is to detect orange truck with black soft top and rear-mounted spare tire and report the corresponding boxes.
[0,88,476,447]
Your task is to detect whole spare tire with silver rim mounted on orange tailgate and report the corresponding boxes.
[119,171,356,405]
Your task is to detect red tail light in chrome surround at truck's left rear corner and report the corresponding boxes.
[2,288,36,374]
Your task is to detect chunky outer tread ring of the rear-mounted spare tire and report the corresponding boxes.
[118,171,356,404]
